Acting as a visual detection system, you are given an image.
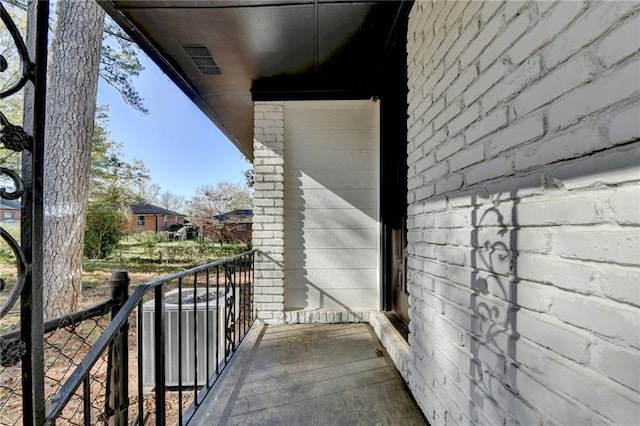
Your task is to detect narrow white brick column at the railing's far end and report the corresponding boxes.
[253,102,284,324]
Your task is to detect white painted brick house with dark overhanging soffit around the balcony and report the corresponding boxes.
[101,0,640,425]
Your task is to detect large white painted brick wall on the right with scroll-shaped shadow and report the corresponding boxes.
[406,0,640,425]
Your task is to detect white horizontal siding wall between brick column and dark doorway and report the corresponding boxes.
[284,101,379,311]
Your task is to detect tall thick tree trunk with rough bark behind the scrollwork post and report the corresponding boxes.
[43,0,104,318]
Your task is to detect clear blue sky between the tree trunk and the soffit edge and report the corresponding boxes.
[98,53,251,199]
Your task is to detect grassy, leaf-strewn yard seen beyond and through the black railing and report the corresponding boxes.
[0,232,247,423]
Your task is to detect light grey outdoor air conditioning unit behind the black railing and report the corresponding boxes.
[138,288,239,387]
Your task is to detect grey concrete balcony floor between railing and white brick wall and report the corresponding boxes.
[190,324,427,426]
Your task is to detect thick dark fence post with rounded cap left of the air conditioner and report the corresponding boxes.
[105,270,130,426]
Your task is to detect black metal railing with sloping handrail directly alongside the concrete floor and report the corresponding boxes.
[55,251,255,425]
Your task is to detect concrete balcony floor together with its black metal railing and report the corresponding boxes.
[0,251,427,425]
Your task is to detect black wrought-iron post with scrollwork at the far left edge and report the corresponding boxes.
[0,1,49,425]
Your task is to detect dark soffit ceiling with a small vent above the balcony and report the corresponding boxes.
[99,0,411,159]
